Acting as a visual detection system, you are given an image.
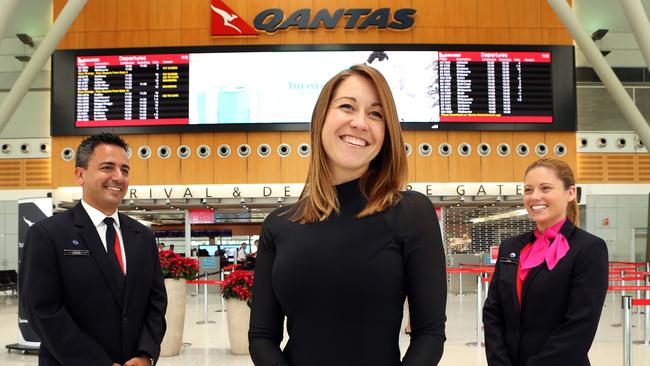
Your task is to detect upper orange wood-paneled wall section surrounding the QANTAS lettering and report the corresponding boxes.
[54,0,571,49]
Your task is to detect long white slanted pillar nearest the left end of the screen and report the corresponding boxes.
[0,0,88,133]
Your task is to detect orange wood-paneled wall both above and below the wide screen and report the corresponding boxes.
[45,0,584,187]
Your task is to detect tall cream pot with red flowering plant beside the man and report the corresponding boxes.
[158,250,199,357]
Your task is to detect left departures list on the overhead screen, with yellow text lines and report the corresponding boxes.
[76,54,189,127]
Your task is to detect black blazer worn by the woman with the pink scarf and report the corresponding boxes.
[483,220,608,366]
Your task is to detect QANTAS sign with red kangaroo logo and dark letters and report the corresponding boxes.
[211,0,415,36]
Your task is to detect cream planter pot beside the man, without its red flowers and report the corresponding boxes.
[160,278,186,357]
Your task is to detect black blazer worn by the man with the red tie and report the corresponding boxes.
[19,204,167,366]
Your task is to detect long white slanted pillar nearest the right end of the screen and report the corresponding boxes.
[547,0,650,149]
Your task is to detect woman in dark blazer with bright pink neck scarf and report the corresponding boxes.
[483,158,608,366]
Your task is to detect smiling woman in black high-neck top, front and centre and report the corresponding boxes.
[249,65,446,366]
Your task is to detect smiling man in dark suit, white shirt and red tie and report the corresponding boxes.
[19,133,167,366]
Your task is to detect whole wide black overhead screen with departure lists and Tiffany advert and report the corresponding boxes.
[52,45,576,135]
